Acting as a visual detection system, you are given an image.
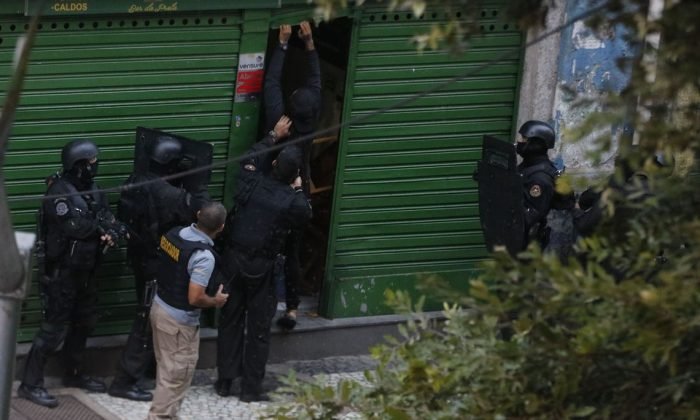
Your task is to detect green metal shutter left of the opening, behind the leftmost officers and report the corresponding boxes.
[0,14,241,341]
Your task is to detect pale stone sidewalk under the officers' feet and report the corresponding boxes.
[10,355,375,420]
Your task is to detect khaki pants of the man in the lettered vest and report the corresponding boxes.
[148,302,199,420]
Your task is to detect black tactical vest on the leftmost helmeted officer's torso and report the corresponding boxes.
[43,178,99,267]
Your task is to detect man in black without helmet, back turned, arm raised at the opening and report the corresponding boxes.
[215,116,311,402]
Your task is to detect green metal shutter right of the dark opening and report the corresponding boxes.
[321,5,523,317]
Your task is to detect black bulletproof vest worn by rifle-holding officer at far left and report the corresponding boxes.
[43,178,99,260]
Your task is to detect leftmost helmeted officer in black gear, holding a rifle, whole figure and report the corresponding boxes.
[17,140,126,408]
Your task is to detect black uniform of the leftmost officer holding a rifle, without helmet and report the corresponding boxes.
[22,175,114,387]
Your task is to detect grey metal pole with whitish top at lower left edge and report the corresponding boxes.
[0,232,35,420]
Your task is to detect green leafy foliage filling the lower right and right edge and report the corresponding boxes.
[275,0,700,419]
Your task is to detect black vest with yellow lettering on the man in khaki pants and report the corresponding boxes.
[157,226,218,311]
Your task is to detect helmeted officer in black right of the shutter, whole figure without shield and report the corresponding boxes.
[515,120,558,249]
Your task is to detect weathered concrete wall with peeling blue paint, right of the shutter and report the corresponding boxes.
[518,0,634,177]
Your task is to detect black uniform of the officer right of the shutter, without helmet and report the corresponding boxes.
[518,154,557,248]
